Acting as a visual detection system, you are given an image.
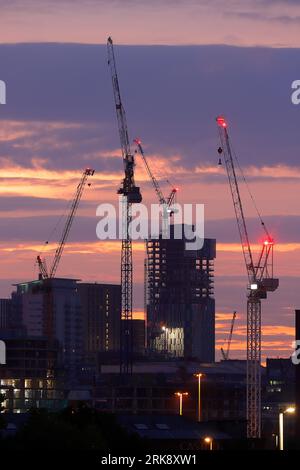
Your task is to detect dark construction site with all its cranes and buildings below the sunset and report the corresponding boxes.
[0,37,296,450]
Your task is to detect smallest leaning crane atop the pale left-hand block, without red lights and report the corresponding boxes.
[37,168,95,279]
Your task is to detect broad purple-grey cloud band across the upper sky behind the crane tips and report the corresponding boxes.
[0,44,299,172]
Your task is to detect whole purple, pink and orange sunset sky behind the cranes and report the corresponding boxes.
[0,0,300,358]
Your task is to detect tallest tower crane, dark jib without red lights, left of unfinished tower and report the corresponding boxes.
[107,37,142,374]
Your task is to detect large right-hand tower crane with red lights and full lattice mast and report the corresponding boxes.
[216,116,279,438]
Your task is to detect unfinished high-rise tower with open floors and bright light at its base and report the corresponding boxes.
[145,226,216,362]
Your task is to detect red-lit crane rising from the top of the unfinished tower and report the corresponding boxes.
[134,139,177,238]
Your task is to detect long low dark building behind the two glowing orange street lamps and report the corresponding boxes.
[95,359,246,423]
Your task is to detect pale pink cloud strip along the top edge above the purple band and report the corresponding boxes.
[0,0,299,47]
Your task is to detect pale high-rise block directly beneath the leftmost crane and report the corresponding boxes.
[12,278,83,378]
